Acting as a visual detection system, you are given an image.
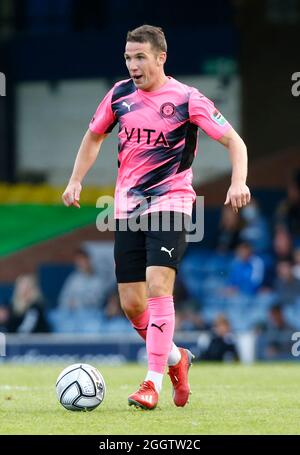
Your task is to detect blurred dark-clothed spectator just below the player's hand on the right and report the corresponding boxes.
[215,205,242,253]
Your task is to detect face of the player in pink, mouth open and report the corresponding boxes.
[124,41,166,91]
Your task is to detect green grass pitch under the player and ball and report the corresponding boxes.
[0,363,300,435]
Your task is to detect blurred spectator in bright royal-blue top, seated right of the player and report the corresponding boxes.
[225,242,265,295]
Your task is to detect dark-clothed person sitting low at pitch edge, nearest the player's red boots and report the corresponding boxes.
[200,315,239,362]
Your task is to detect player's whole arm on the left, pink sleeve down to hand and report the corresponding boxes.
[62,88,117,208]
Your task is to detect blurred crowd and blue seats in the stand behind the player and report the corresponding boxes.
[0,170,300,360]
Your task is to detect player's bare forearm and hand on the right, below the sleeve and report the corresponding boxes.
[218,128,251,212]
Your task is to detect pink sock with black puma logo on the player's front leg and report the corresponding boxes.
[146,296,175,374]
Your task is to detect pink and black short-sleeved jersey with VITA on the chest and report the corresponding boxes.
[89,77,231,218]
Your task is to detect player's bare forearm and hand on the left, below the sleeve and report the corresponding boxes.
[62,129,107,208]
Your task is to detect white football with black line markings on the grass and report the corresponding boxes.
[56,363,106,411]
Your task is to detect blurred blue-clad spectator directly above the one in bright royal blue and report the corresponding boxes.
[240,198,271,253]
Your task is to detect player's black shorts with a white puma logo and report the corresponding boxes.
[114,212,190,283]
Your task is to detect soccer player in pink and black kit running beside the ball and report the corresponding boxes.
[63,25,250,409]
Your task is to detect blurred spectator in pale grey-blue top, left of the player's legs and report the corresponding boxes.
[58,249,105,310]
